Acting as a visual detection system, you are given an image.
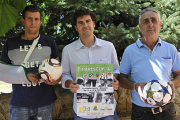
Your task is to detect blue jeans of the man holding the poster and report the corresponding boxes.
[74,111,118,120]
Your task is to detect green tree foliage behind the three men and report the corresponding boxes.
[0,0,180,59]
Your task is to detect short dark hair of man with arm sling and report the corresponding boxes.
[22,5,42,19]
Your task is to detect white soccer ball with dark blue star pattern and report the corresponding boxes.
[143,80,172,106]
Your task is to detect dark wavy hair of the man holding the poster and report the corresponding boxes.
[72,8,96,26]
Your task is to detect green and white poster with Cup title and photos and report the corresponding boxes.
[76,64,115,116]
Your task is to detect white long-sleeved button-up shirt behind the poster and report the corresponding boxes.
[61,37,119,119]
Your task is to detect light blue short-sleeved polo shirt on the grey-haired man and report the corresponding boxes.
[119,38,180,107]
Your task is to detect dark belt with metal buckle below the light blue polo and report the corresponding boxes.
[133,102,174,114]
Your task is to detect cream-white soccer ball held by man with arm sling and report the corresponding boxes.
[39,58,63,81]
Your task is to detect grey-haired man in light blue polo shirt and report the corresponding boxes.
[119,8,180,120]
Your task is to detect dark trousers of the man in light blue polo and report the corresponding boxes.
[131,102,176,120]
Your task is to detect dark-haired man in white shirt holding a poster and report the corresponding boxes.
[61,8,119,120]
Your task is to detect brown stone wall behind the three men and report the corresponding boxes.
[0,85,180,120]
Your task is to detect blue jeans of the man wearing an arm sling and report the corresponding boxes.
[9,104,53,120]
